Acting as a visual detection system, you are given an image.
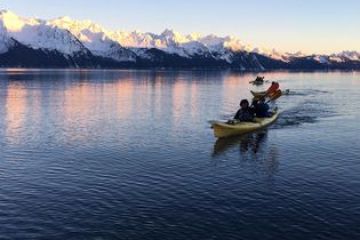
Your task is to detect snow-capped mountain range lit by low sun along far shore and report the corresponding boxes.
[0,10,360,71]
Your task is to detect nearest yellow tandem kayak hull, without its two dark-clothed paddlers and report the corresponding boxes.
[212,111,279,138]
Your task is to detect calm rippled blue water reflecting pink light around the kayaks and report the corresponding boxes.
[0,70,360,240]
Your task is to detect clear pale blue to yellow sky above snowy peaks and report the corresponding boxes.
[0,0,360,54]
